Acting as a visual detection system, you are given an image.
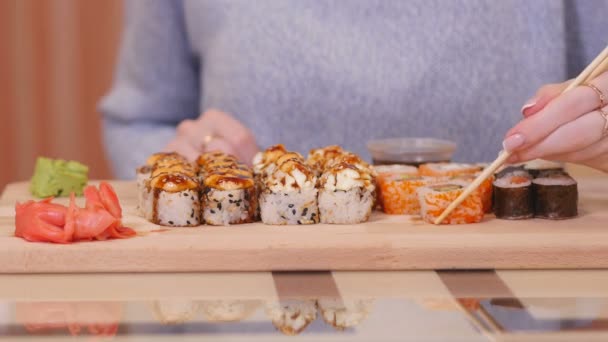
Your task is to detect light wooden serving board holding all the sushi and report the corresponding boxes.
[0,178,608,273]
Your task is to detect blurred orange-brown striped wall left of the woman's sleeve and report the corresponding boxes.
[0,0,123,191]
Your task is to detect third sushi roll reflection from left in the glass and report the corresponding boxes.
[266,299,317,336]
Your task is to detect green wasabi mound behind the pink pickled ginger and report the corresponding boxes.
[30,157,89,198]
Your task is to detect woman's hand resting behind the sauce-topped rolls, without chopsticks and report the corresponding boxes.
[165,109,258,164]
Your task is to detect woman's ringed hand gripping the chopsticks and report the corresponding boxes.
[503,73,608,172]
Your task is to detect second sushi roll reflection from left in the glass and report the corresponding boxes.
[199,300,261,322]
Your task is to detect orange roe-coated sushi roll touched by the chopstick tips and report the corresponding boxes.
[417,181,484,224]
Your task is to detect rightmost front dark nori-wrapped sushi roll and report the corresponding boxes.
[532,172,578,220]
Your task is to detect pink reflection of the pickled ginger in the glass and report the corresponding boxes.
[15,302,123,336]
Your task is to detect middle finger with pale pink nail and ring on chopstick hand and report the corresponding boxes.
[503,73,608,152]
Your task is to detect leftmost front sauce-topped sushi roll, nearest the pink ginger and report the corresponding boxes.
[144,171,200,227]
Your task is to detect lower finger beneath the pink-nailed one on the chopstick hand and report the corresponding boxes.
[510,111,605,161]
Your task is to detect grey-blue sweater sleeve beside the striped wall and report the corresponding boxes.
[99,0,200,178]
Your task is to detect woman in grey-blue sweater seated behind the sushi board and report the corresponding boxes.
[101,0,608,178]
